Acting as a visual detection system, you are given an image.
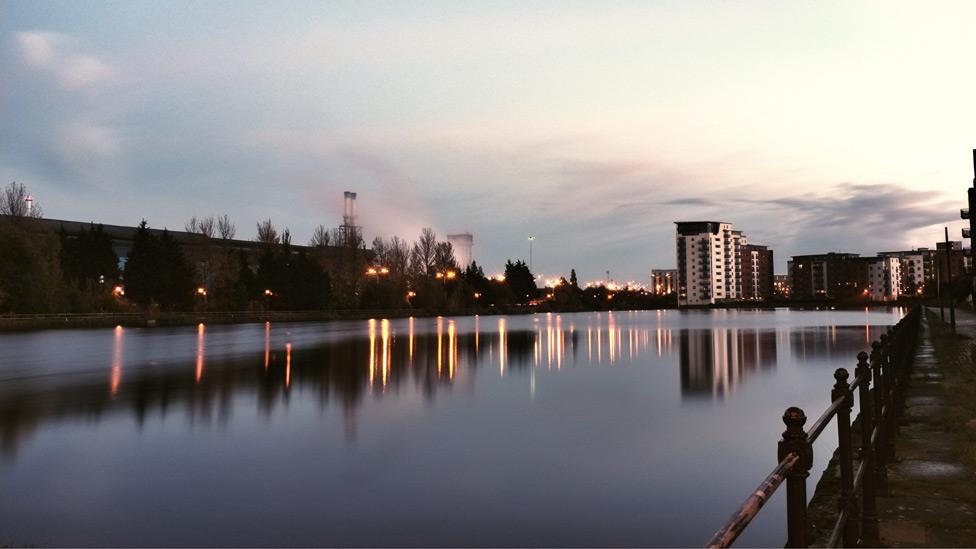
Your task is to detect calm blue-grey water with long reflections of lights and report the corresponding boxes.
[0,310,901,546]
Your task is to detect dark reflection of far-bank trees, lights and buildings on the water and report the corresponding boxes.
[0,313,896,453]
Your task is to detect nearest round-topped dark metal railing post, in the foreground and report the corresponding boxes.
[777,406,813,547]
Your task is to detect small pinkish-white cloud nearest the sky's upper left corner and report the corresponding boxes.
[16,31,112,90]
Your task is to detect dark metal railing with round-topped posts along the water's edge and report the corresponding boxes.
[707,306,922,547]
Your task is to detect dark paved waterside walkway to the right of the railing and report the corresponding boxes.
[878,309,976,547]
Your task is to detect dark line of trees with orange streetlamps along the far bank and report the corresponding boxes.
[0,183,676,313]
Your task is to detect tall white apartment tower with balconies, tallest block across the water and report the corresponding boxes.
[675,221,747,305]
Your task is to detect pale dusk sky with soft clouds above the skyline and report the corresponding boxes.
[0,0,976,281]
